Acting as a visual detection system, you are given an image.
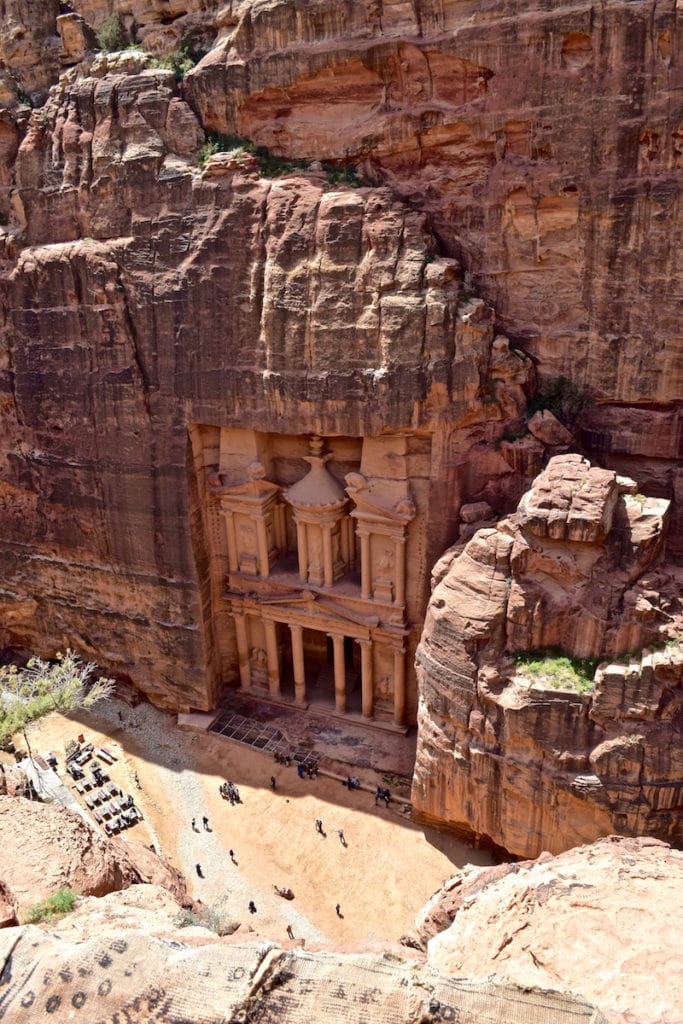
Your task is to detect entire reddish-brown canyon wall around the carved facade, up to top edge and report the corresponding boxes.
[0,0,683,709]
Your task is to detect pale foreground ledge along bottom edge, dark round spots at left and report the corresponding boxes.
[0,917,605,1024]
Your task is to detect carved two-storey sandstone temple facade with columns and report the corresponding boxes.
[207,428,419,728]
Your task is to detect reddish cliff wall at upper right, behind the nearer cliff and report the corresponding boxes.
[187,0,683,407]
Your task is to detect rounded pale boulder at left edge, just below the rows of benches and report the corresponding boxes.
[0,797,189,906]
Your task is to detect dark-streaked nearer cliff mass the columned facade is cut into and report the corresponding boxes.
[2,52,530,708]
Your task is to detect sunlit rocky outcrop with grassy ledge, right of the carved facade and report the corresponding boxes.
[413,455,683,856]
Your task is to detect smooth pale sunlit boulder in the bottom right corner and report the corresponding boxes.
[418,837,683,1024]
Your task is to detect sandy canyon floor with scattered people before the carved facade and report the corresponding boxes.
[7,701,492,945]
